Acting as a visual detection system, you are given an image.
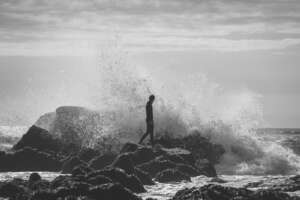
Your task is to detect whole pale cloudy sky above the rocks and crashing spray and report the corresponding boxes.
[0,0,300,128]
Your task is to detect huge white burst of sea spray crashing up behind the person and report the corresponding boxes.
[88,45,300,174]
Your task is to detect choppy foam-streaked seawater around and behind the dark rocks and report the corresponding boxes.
[0,126,300,200]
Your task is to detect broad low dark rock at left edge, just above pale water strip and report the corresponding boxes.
[0,147,61,171]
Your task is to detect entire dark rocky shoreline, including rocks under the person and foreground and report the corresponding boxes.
[0,107,300,200]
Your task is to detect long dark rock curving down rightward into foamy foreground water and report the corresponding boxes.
[88,168,146,193]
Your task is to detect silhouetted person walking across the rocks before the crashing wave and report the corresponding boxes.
[139,95,155,146]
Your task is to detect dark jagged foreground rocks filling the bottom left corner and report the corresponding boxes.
[0,173,141,200]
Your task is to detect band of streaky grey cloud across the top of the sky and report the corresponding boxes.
[0,0,300,54]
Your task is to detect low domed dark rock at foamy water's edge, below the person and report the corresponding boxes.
[155,169,191,183]
